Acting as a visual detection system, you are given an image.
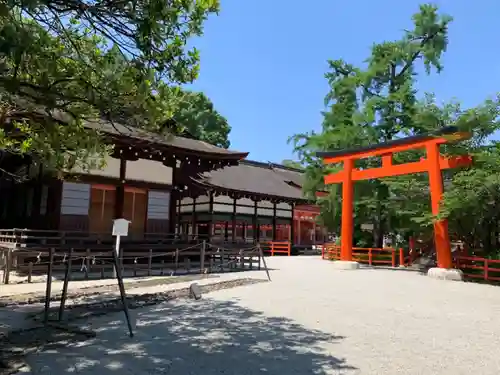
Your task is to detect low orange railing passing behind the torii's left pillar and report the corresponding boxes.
[321,244,406,267]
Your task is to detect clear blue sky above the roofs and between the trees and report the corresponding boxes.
[188,0,500,162]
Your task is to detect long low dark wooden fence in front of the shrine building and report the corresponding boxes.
[0,241,263,284]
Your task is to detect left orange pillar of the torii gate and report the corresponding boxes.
[340,159,354,261]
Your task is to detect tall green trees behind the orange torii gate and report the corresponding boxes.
[291,5,500,256]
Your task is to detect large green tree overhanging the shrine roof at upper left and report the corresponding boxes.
[0,0,219,173]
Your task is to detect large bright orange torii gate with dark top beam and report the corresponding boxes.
[316,127,472,269]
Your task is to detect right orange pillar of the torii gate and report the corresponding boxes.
[427,143,452,268]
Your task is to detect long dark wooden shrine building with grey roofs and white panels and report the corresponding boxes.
[0,122,326,248]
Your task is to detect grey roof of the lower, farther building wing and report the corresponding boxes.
[197,160,304,200]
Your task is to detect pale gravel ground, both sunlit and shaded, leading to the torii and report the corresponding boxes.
[11,257,500,375]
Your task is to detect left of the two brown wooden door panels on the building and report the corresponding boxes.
[89,185,116,234]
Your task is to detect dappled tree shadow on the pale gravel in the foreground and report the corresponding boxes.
[16,298,356,375]
